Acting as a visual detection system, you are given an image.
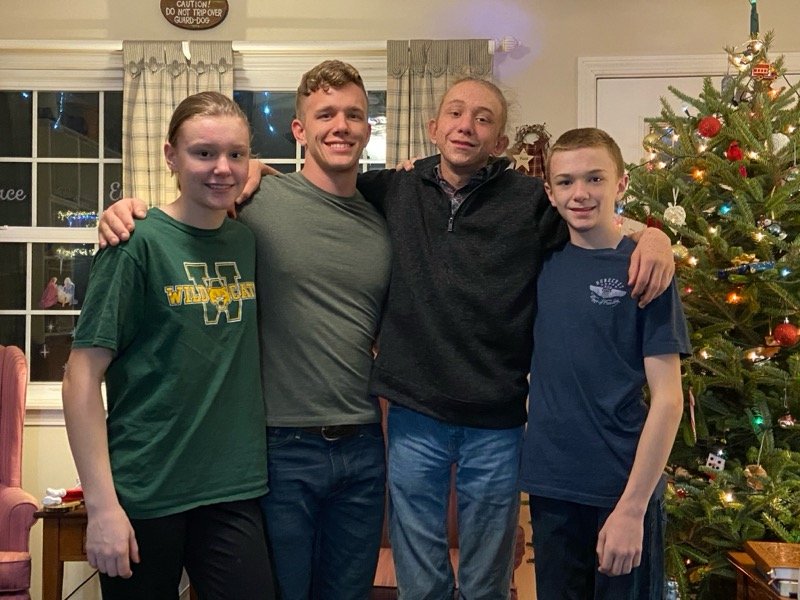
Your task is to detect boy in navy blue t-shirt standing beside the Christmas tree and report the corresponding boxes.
[520,128,690,600]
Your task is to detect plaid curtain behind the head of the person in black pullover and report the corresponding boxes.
[386,40,492,168]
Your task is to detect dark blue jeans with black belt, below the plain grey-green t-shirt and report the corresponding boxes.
[261,423,386,600]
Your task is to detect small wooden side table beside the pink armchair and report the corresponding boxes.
[34,507,86,600]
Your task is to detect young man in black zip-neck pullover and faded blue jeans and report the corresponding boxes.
[358,79,674,600]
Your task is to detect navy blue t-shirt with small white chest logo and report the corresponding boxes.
[520,238,691,507]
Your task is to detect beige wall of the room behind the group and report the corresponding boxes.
[10,0,800,600]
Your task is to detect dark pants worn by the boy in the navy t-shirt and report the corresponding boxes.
[530,493,666,600]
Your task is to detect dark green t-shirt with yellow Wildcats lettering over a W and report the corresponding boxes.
[73,209,267,519]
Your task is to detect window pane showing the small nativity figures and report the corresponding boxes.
[31,243,94,310]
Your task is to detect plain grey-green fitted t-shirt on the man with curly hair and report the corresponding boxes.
[240,173,391,427]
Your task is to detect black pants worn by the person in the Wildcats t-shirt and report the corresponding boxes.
[100,499,275,600]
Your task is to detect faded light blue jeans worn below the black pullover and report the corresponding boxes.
[388,404,522,600]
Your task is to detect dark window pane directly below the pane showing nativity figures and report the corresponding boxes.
[31,315,78,381]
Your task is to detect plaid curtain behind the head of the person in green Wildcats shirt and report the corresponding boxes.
[122,41,233,206]
